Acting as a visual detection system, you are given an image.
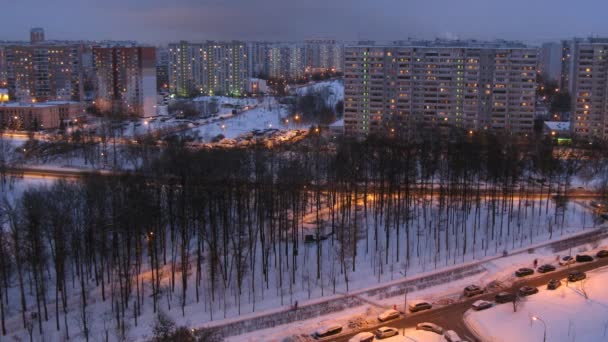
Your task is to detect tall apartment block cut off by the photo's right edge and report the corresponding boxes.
[569,38,608,140]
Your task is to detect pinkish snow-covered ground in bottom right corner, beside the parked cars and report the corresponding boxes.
[465,267,608,342]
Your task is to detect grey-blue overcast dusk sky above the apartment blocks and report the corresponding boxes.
[0,0,608,44]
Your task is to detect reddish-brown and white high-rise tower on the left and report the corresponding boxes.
[93,46,157,117]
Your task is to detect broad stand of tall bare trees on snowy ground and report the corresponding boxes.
[0,132,608,340]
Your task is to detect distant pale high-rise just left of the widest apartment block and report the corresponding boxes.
[305,39,344,73]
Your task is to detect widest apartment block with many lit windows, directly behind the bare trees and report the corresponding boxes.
[344,41,538,135]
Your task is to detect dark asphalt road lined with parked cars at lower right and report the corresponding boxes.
[330,258,608,342]
